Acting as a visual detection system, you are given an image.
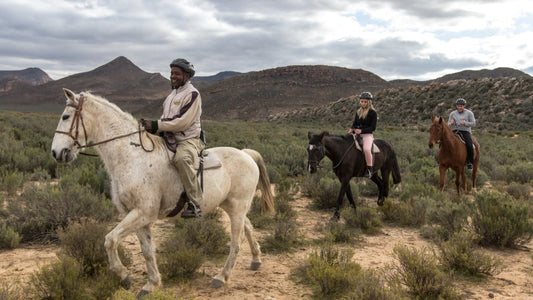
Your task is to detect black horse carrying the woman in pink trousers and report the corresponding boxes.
[307,131,402,219]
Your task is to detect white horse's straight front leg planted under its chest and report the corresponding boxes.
[137,225,161,293]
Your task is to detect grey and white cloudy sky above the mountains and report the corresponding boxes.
[0,0,533,80]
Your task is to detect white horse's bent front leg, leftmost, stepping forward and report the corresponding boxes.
[104,209,151,282]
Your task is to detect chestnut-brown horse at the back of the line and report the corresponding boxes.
[428,117,480,194]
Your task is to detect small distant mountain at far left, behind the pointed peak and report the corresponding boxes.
[0,68,52,93]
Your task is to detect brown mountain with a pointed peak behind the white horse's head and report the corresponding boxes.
[0,56,170,112]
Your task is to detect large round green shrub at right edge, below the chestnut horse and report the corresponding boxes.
[472,191,533,247]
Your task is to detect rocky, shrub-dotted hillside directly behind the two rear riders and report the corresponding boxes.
[269,76,533,131]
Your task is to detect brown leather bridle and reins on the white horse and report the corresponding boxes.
[55,95,154,156]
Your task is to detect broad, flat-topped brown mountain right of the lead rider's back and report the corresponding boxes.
[200,65,389,120]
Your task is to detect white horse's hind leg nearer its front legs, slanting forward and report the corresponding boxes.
[211,214,244,288]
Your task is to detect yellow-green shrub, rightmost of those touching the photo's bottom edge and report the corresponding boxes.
[391,245,459,299]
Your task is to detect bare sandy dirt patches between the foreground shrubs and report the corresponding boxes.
[0,192,533,300]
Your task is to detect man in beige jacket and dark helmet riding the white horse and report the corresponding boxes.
[141,58,205,218]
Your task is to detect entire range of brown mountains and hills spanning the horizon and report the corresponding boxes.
[0,56,533,129]
